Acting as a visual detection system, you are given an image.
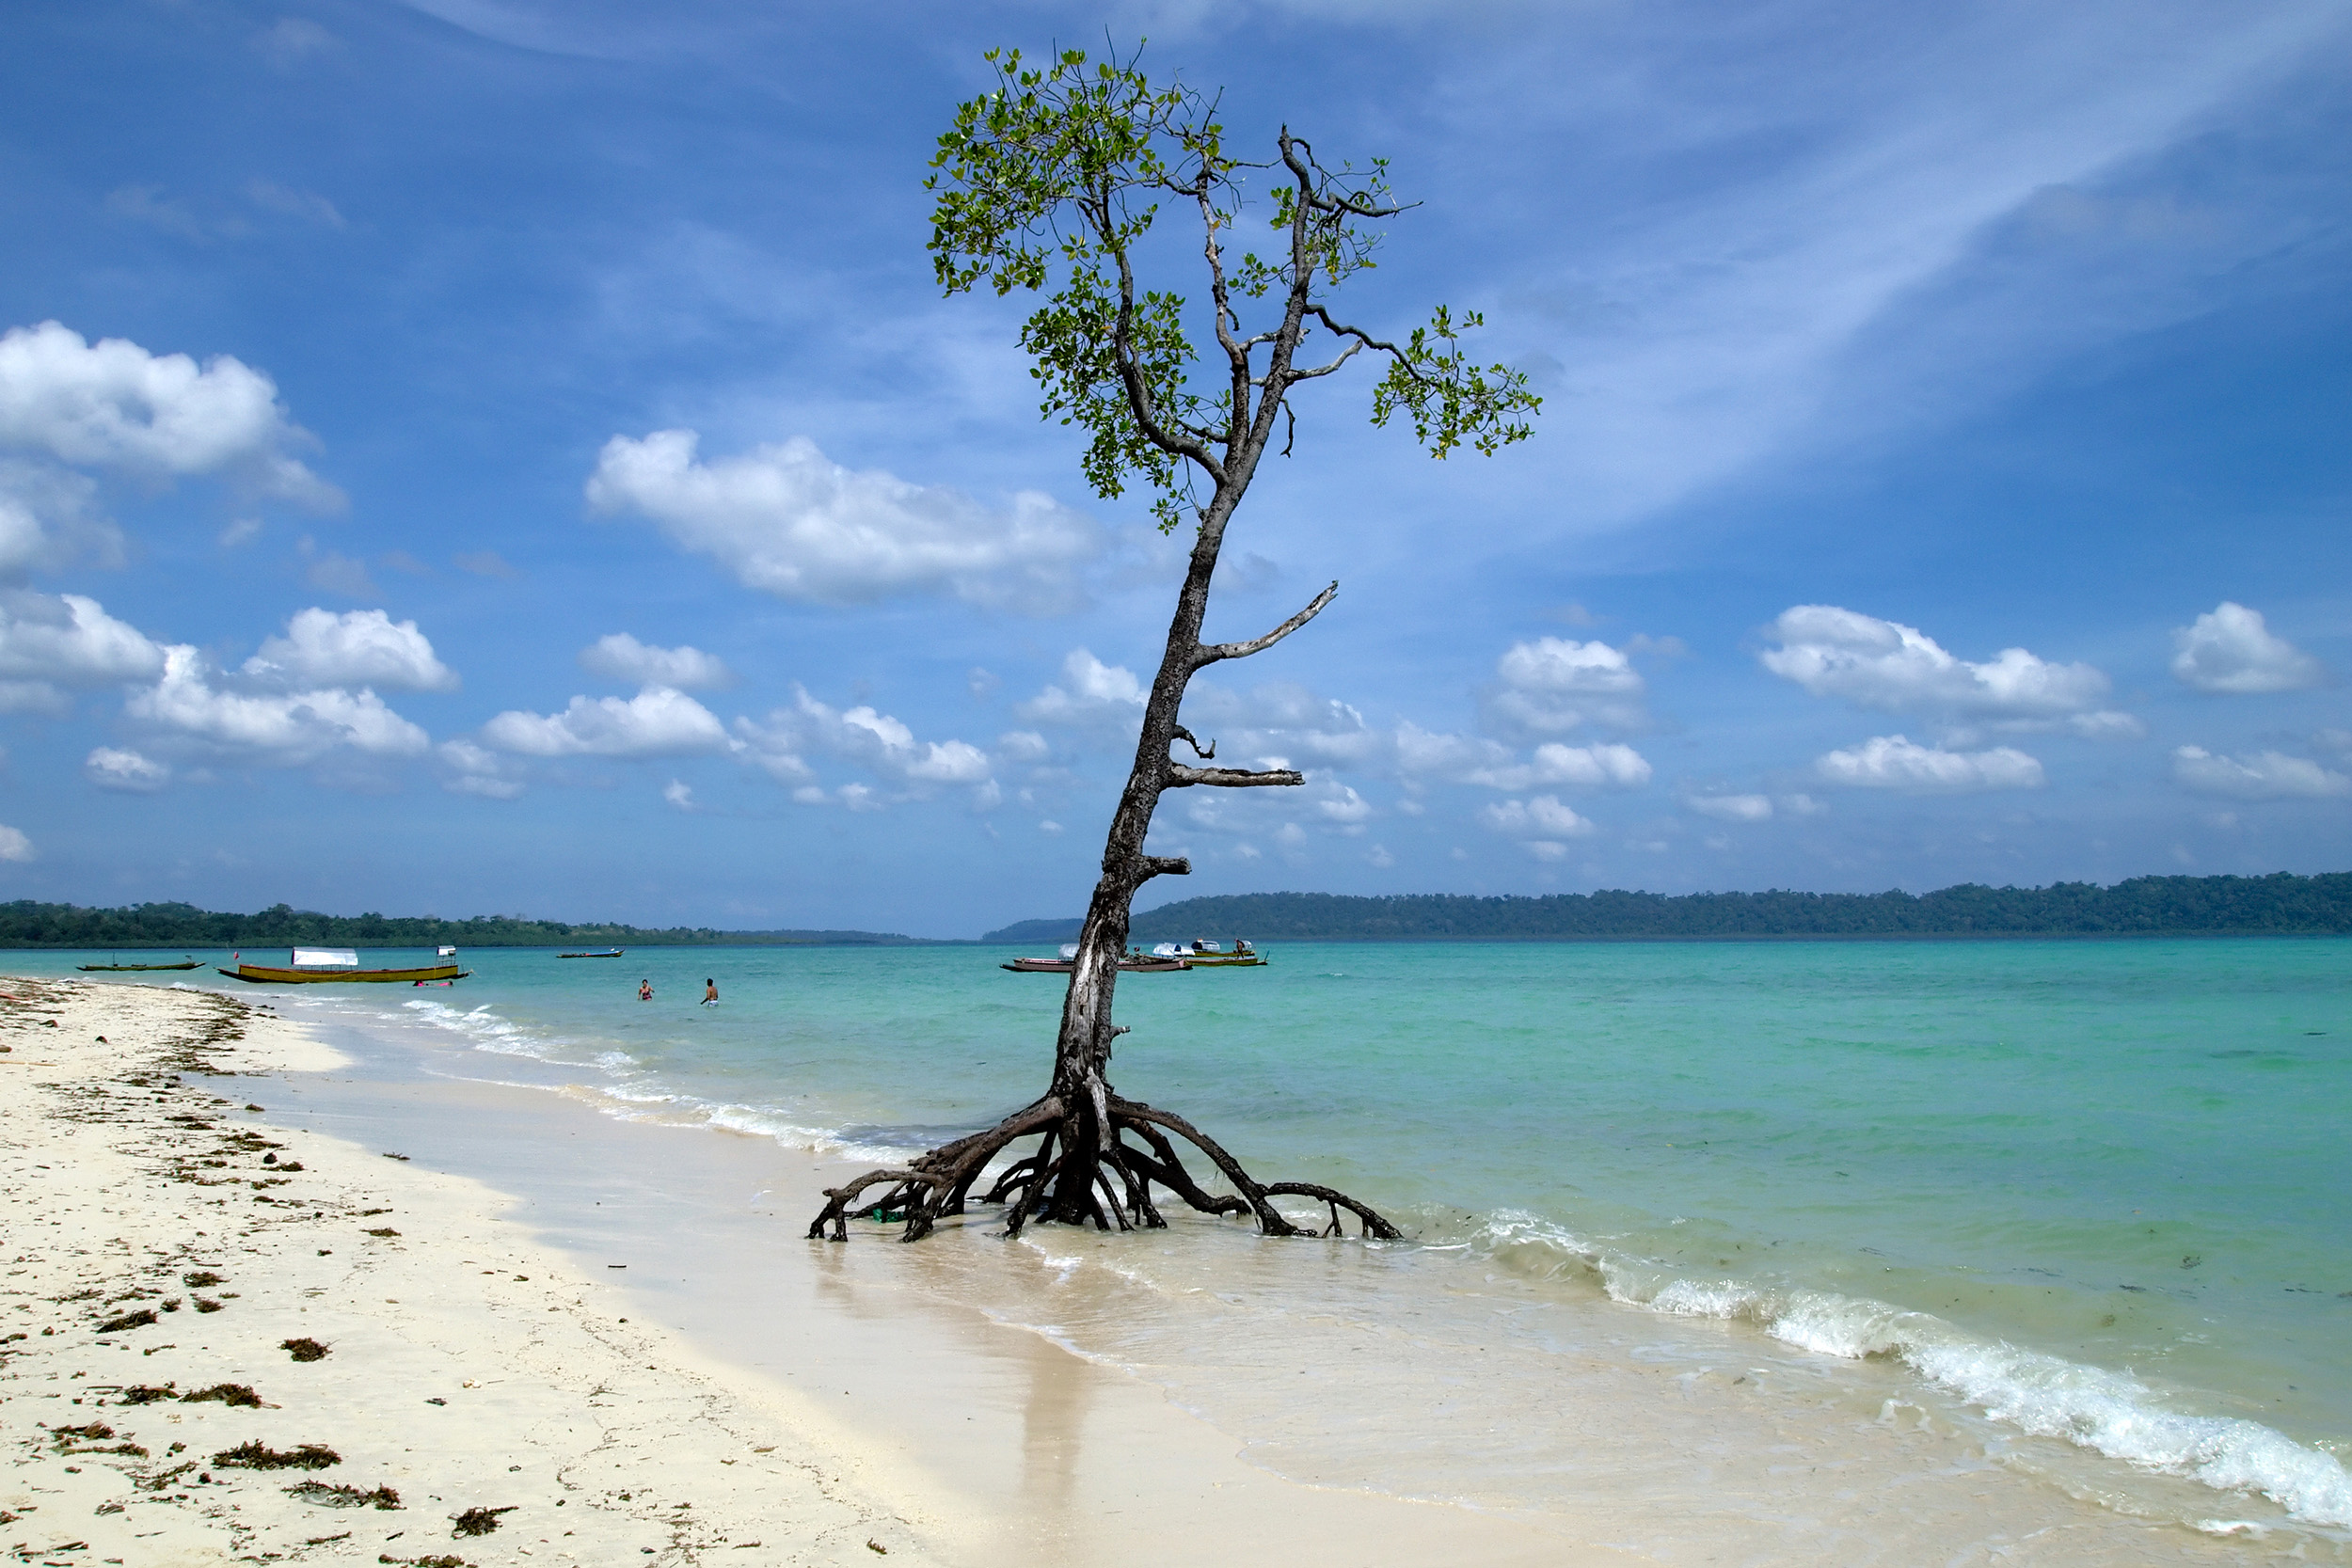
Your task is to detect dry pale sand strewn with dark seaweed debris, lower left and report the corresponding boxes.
[0,978,927,1568]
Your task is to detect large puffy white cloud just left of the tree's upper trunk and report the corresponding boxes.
[588,430,1108,613]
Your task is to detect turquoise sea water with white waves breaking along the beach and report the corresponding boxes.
[12,941,2352,1549]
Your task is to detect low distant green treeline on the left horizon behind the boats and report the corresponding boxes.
[0,900,920,952]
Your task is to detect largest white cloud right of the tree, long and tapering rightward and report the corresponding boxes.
[1759,604,2145,738]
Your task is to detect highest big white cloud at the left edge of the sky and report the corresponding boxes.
[0,322,343,510]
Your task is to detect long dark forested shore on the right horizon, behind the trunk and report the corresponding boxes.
[983,872,2352,942]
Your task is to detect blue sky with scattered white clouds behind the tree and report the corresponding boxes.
[0,0,2352,936]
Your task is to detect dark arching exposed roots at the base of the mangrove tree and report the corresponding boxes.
[809,1096,1402,1242]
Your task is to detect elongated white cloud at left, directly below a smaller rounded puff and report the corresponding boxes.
[122,646,431,767]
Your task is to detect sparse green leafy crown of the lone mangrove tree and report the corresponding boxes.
[925,49,1543,529]
